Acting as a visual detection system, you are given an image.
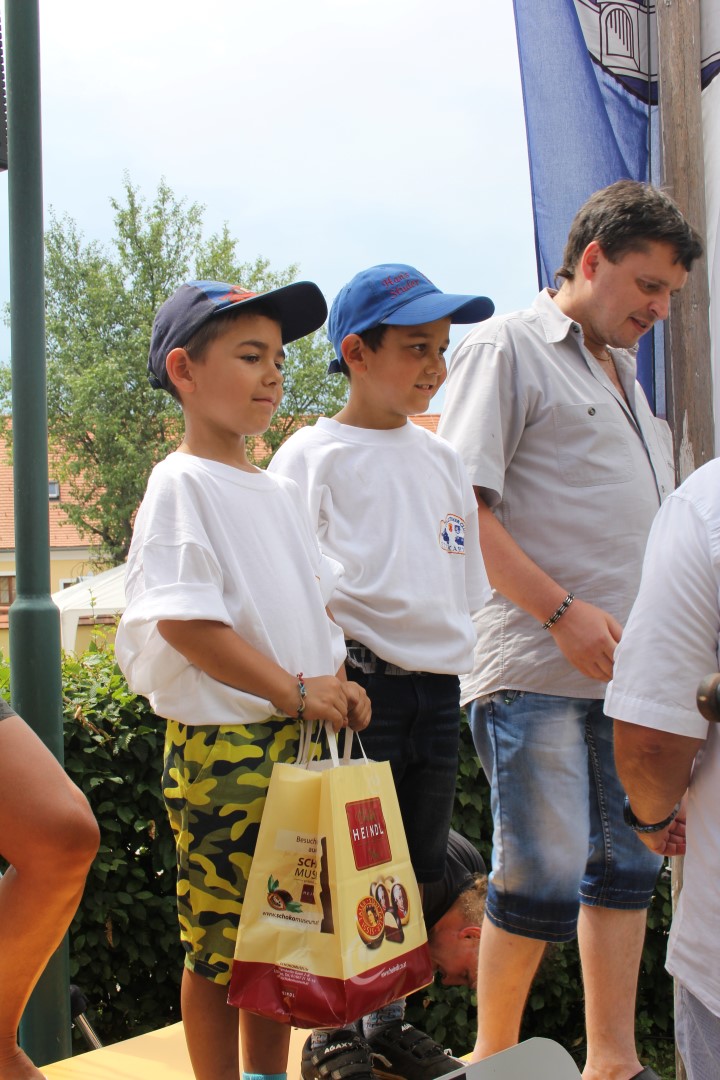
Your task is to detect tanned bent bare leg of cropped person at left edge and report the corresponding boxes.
[0,716,99,1080]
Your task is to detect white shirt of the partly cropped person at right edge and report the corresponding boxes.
[604,459,720,1016]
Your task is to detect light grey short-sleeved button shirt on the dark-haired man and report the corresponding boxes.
[439,291,675,701]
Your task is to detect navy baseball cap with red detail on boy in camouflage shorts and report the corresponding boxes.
[148,281,327,390]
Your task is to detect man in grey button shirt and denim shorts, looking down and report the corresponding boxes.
[439,180,702,1080]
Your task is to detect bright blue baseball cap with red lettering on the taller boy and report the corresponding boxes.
[327,262,495,374]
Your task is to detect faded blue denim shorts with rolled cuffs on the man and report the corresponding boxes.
[470,690,662,942]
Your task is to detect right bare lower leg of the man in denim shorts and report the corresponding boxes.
[578,904,647,1080]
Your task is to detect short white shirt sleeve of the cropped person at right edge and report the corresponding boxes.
[604,488,720,739]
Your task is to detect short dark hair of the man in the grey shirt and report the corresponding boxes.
[555,180,703,281]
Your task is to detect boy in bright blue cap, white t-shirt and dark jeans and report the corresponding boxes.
[270,265,493,1080]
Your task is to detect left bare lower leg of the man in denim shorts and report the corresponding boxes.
[472,919,545,1062]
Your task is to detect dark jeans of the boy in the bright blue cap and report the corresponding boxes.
[348,667,460,882]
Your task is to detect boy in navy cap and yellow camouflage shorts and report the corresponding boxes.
[116,281,369,1080]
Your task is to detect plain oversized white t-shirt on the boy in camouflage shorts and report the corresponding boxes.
[116,454,345,725]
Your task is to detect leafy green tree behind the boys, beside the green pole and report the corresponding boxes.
[0,175,344,566]
